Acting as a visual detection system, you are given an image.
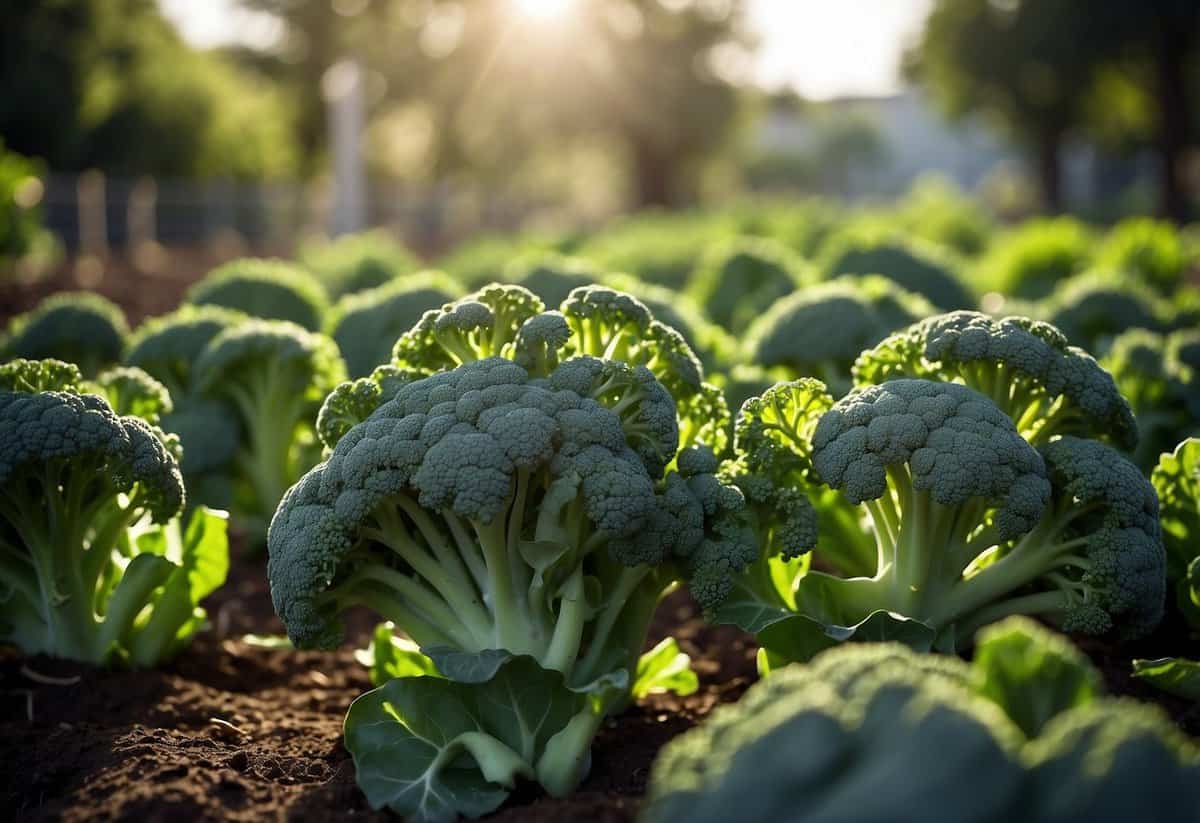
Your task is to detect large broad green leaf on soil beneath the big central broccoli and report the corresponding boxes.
[344,650,602,821]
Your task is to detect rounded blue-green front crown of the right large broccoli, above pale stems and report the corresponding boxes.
[812,379,1050,537]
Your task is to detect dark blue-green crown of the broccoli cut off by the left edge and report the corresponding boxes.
[0,391,184,523]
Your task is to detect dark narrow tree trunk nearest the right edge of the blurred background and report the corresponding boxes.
[1154,13,1192,223]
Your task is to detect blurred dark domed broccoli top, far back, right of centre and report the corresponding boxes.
[821,232,976,311]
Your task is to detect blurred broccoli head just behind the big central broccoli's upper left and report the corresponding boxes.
[326,271,462,378]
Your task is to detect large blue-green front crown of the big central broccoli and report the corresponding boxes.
[269,358,686,643]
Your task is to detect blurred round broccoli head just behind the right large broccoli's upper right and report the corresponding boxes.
[1043,272,1170,352]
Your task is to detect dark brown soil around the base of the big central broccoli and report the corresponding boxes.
[0,551,755,823]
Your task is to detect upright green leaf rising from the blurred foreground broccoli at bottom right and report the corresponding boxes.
[972,617,1104,739]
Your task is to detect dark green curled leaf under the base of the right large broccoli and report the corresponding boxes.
[756,611,936,674]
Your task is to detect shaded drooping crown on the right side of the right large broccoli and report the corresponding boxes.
[1042,435,1166,637]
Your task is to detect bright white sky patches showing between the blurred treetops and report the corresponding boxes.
[160,0,932,100]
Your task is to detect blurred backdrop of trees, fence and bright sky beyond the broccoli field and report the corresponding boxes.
[0,0,1200,287]
